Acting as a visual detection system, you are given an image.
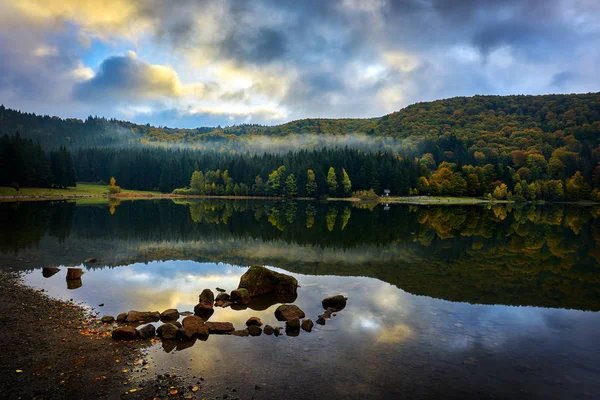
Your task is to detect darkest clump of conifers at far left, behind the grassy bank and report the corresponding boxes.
[0,133,76,189]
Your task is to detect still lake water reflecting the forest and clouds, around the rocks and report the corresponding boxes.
[0,199,600,399]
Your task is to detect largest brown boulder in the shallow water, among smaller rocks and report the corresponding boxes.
[238,265,298,297]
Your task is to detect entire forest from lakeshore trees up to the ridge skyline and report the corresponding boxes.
[0,93,600,201]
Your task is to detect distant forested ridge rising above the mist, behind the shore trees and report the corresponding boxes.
[0,93,600,148]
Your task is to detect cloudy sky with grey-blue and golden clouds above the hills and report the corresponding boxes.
[0,0,600,128]
